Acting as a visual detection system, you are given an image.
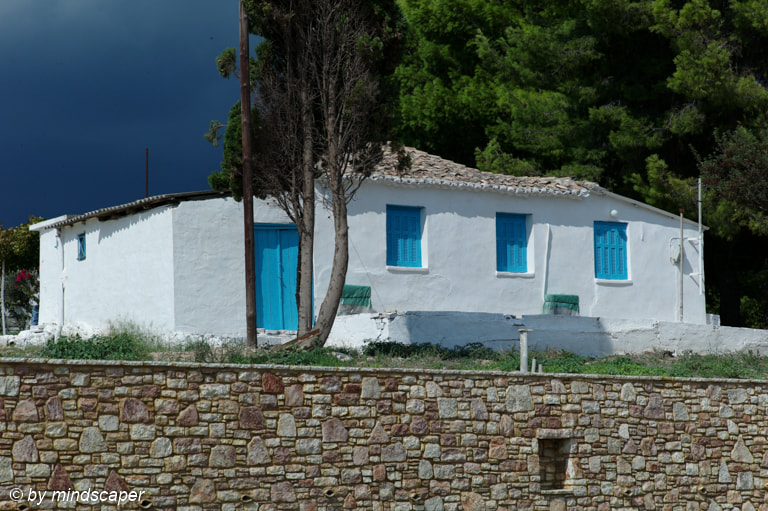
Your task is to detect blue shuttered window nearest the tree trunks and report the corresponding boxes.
[387,205,422,268]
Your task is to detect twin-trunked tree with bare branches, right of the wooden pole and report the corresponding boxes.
[252,0,396,349]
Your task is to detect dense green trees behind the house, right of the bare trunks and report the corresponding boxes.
[396,0,768,324]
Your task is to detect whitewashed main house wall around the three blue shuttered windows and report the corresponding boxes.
[315,182,706,323]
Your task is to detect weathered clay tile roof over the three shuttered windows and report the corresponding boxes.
[370,147,599,197]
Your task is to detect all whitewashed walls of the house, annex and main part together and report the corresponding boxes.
[33,181,706,344]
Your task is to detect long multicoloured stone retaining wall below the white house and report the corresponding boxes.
[0,359,768,511]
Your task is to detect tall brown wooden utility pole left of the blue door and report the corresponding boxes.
[240,0,258,346]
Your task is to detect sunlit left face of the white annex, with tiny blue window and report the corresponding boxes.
[40,206,174,332]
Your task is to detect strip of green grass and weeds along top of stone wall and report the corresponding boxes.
[0,324,768,379]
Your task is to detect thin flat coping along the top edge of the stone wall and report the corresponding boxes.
[0,357,768,385]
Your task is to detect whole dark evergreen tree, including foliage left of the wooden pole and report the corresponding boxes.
[208,0,401,341]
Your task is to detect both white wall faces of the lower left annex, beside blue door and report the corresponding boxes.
[32,198,290,337]
